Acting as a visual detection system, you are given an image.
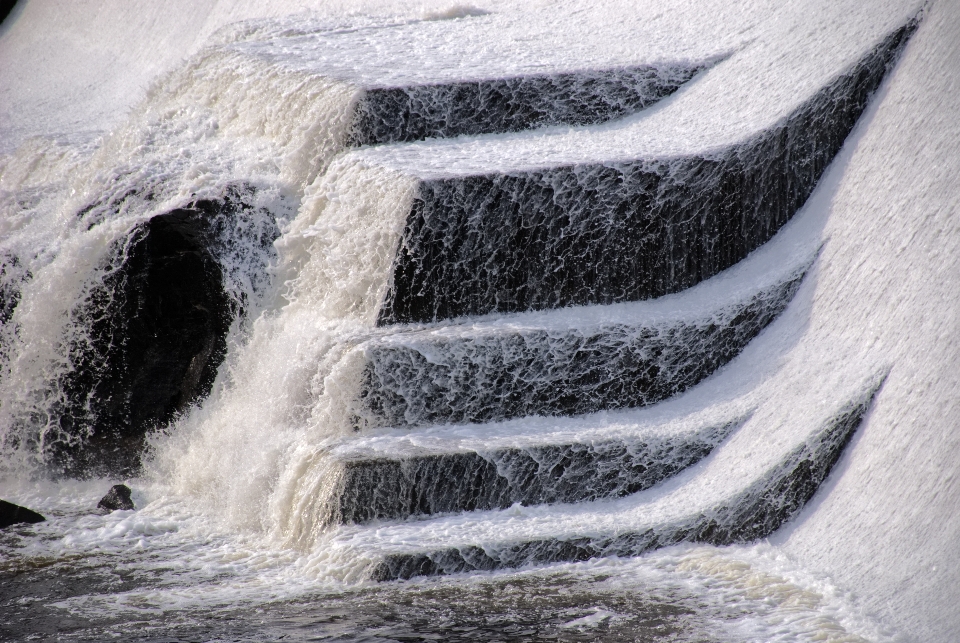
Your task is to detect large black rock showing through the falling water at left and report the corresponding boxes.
[51,182,277,476]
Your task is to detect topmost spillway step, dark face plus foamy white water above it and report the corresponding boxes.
[216,16,708,149]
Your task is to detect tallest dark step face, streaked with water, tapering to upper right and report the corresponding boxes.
[378,23,916,325]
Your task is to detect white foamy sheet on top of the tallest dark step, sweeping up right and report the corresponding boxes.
[353,0,920,179]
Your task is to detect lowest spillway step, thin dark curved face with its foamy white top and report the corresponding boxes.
[352,374,879,580]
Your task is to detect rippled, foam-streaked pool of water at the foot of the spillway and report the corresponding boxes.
[0,480,887,643]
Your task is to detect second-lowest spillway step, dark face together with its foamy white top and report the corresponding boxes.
[319,412,743,524]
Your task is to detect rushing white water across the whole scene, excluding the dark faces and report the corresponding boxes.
[0,0,960,643]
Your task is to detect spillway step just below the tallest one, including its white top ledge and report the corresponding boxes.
[348,230,816,428]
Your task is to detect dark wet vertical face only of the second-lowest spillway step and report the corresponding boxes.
[318,422,739,523]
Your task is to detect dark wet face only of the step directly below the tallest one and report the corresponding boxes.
[360,271,805,427]
